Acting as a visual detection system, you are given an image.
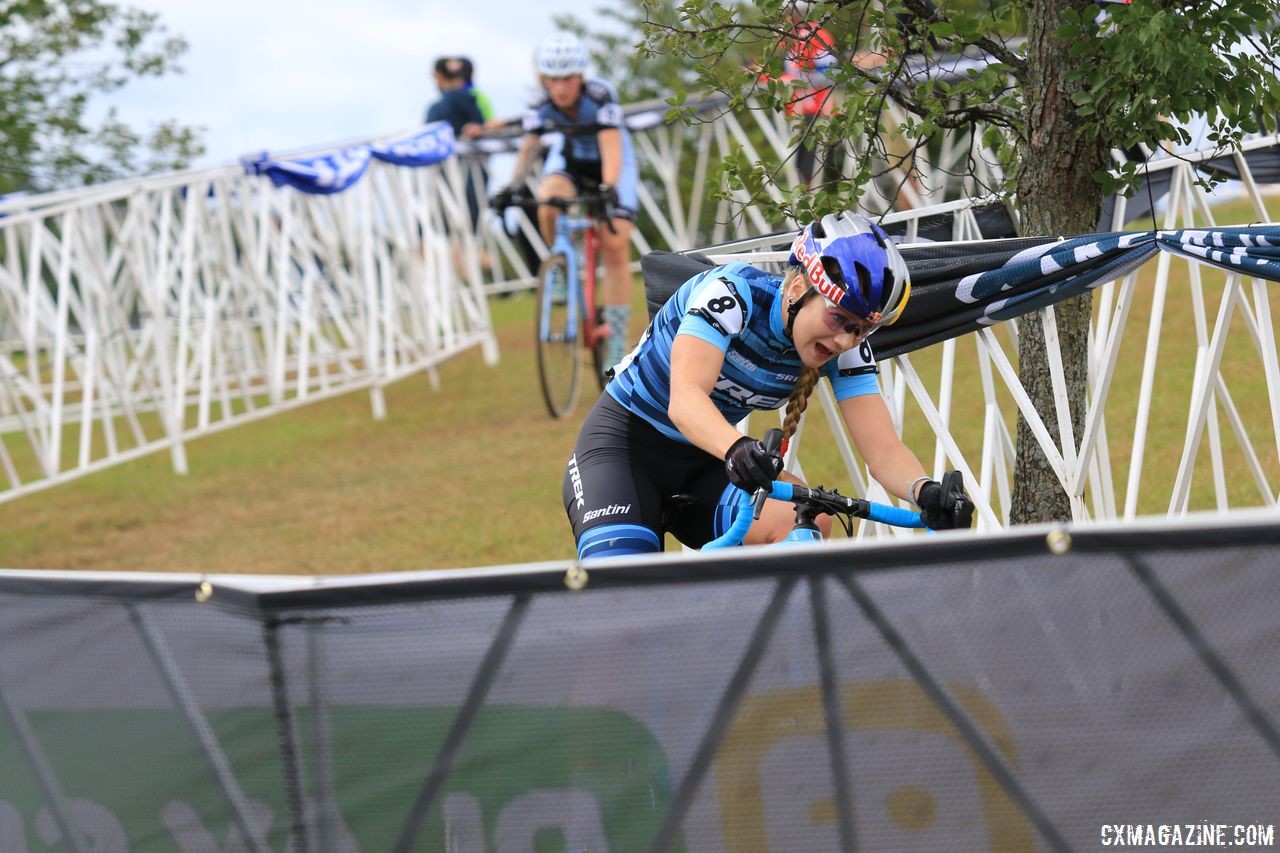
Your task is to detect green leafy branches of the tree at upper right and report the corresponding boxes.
[604,0,1280,233]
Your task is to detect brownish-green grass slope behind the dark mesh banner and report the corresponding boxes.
[0,194,1280,574]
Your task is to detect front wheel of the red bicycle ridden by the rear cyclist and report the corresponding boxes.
[534,254,582,418]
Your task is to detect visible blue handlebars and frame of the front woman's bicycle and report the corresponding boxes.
[703,429,928,551]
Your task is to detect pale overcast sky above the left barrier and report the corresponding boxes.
[111,0,619,165]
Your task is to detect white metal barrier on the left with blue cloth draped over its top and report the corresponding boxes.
[0,137,498,501]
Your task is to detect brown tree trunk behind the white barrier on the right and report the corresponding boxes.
[1010,0,1108,524]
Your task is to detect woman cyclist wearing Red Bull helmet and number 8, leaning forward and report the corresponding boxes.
[563,213,973,558]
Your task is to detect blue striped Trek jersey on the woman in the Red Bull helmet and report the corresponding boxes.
[605,264,879,443]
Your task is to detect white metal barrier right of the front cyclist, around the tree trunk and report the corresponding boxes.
[703,140,1280,535]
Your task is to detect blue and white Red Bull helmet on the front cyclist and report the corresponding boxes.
[790,210,911,327]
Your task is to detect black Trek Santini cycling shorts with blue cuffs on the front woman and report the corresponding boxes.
[563,392,731,557]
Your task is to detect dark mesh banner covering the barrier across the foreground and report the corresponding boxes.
[0,516,1280,853]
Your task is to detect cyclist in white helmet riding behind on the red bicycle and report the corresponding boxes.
[499,33,639,366]
